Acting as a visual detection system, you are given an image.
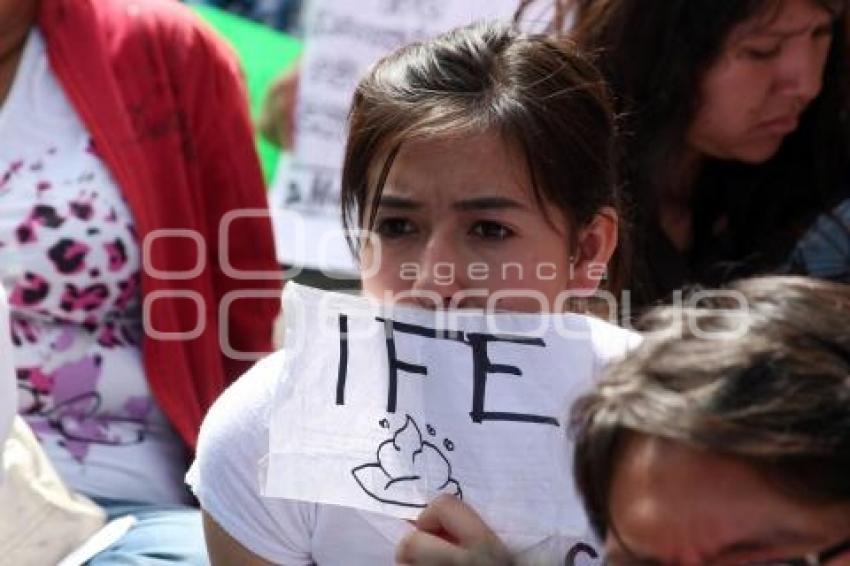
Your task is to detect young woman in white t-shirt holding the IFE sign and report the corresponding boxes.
[189,20,627,565]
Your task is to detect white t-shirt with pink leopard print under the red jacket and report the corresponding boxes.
[0,29,186,503]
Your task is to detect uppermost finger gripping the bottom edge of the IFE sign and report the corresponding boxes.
[416,495,498,547]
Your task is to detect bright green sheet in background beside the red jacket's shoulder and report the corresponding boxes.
[192,6,301,183]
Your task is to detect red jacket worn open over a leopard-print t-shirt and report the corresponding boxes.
[38,0,280,448]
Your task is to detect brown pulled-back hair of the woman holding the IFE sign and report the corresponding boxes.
[342,23,630,289]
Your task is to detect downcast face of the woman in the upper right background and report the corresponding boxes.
[687,0,833,163]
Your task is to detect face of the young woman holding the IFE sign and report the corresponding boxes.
[361,133,616,312]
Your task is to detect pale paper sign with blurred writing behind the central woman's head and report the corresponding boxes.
[270,0,517,275]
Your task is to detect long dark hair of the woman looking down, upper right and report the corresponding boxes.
[517,0,850,301]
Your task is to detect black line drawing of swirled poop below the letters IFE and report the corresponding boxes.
[351,415,463,508]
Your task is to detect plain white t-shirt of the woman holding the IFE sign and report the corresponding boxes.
[187,330,635,566]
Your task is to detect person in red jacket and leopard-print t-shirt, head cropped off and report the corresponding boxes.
[0,0,279,564]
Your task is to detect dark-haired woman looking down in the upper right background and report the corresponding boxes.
[519,0,850,310]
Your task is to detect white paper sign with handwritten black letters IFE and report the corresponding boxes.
[264,284,638,544]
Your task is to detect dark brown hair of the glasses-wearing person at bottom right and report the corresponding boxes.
[572,276,850,537]
